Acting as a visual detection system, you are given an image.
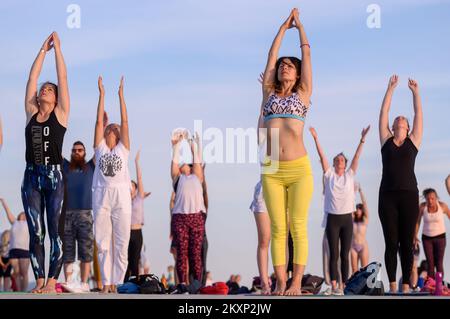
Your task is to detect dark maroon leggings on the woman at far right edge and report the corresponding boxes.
[422,233,447,278]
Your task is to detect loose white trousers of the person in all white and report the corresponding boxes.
[92,187,131,285]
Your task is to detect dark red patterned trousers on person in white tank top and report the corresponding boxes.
[171,213,205,283]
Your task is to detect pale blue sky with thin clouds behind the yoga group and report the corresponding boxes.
[0,0,450,290]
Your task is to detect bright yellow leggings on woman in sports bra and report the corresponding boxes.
[261,155,314,266]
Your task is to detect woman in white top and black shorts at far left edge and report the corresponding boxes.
[0,198,30,291]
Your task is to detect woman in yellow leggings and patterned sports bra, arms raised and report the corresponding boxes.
[261,9,313,295]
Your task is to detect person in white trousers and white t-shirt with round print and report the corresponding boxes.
[92,76,131,293]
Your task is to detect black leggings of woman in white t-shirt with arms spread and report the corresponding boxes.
[325,213,353,283]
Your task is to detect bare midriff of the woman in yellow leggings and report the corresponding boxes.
[265,118,307,161]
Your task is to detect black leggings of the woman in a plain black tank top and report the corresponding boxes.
[378,190,419,284]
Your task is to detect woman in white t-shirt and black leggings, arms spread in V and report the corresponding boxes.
[309,126,370,295]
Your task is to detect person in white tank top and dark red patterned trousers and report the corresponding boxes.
[171,133,206,284]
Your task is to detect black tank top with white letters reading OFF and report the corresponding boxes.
[25,111,66,165]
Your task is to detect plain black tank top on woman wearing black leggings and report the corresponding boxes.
[380,137,418,192]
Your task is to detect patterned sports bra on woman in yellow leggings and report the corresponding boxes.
[263,92,308,122]
